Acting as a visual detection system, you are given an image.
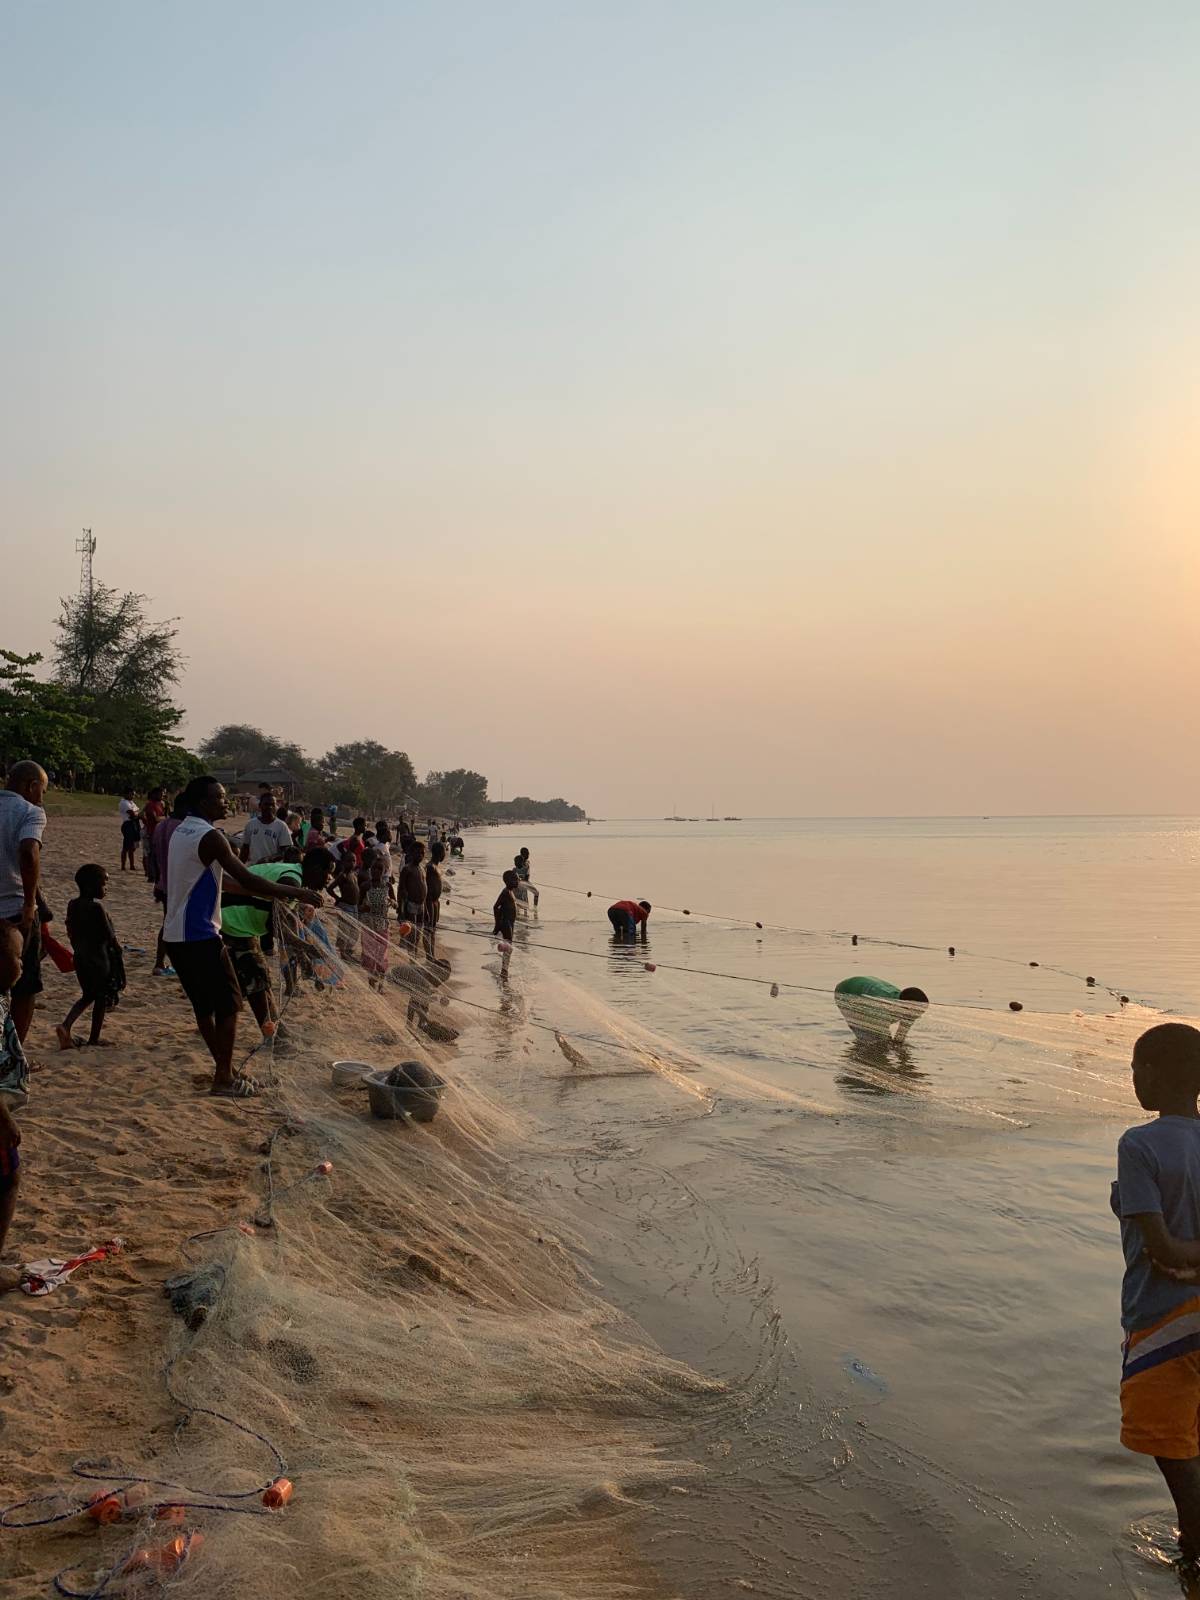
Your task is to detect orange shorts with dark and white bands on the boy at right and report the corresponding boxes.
[1122,1296,1200,1461]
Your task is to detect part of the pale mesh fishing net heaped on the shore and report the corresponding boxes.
[5,912,722,1600]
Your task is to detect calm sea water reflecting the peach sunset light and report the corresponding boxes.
[448,818,1200,1600]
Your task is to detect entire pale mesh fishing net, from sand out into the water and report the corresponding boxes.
[0,838,1196,1600]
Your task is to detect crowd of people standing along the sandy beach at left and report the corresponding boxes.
[0,760,489,1288]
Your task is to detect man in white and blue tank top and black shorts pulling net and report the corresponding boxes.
[163,776,323,1099]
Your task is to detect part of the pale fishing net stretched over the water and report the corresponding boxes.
[428,894,1163,1126]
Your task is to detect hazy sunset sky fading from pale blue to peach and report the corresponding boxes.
[0,0,1200,816]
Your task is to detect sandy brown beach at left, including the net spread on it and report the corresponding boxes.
[0,818,707,1600]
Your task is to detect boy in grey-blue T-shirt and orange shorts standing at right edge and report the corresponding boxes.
[1112,1022,1200,1568]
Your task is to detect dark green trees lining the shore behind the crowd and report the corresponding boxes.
[0,584,584,821]
